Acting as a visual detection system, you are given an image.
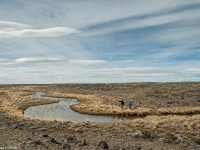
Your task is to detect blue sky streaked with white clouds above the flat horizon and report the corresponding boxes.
[0,0,200,84]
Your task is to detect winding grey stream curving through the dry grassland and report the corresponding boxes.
[24,92,133,122]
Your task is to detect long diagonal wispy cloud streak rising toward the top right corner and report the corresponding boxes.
[83,4,200,36]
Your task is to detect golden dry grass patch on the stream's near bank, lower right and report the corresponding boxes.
[131,115,200,143]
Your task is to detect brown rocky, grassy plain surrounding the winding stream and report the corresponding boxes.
[0,83,200,150]
